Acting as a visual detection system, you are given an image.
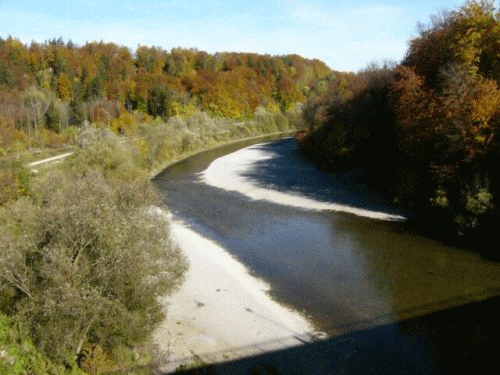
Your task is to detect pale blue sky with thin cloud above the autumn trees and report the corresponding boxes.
[0,0,476,72]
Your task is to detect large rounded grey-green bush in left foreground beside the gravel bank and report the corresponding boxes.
[0,169,185,370]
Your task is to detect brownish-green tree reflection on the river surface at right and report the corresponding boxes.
[332,216,500,328]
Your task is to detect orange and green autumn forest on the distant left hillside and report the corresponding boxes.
[0,37,330,154]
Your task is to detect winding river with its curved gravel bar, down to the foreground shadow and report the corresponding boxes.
[154,138,500,336]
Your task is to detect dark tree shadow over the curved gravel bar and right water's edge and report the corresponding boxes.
[242,138,500,262]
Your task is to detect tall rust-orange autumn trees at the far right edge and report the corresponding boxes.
[394,1,500,232]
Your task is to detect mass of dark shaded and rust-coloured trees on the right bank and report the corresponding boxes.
[300,1,500,239]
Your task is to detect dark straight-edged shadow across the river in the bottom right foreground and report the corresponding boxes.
[169,297,500,375]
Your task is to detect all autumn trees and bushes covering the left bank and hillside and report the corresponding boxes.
[0,33,324,374]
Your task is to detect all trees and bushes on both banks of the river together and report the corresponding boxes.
[0,1,500,374]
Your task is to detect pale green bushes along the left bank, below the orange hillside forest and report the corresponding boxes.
[0,110,300,374]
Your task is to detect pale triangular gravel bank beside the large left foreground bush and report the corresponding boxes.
[153,211,318,372]
